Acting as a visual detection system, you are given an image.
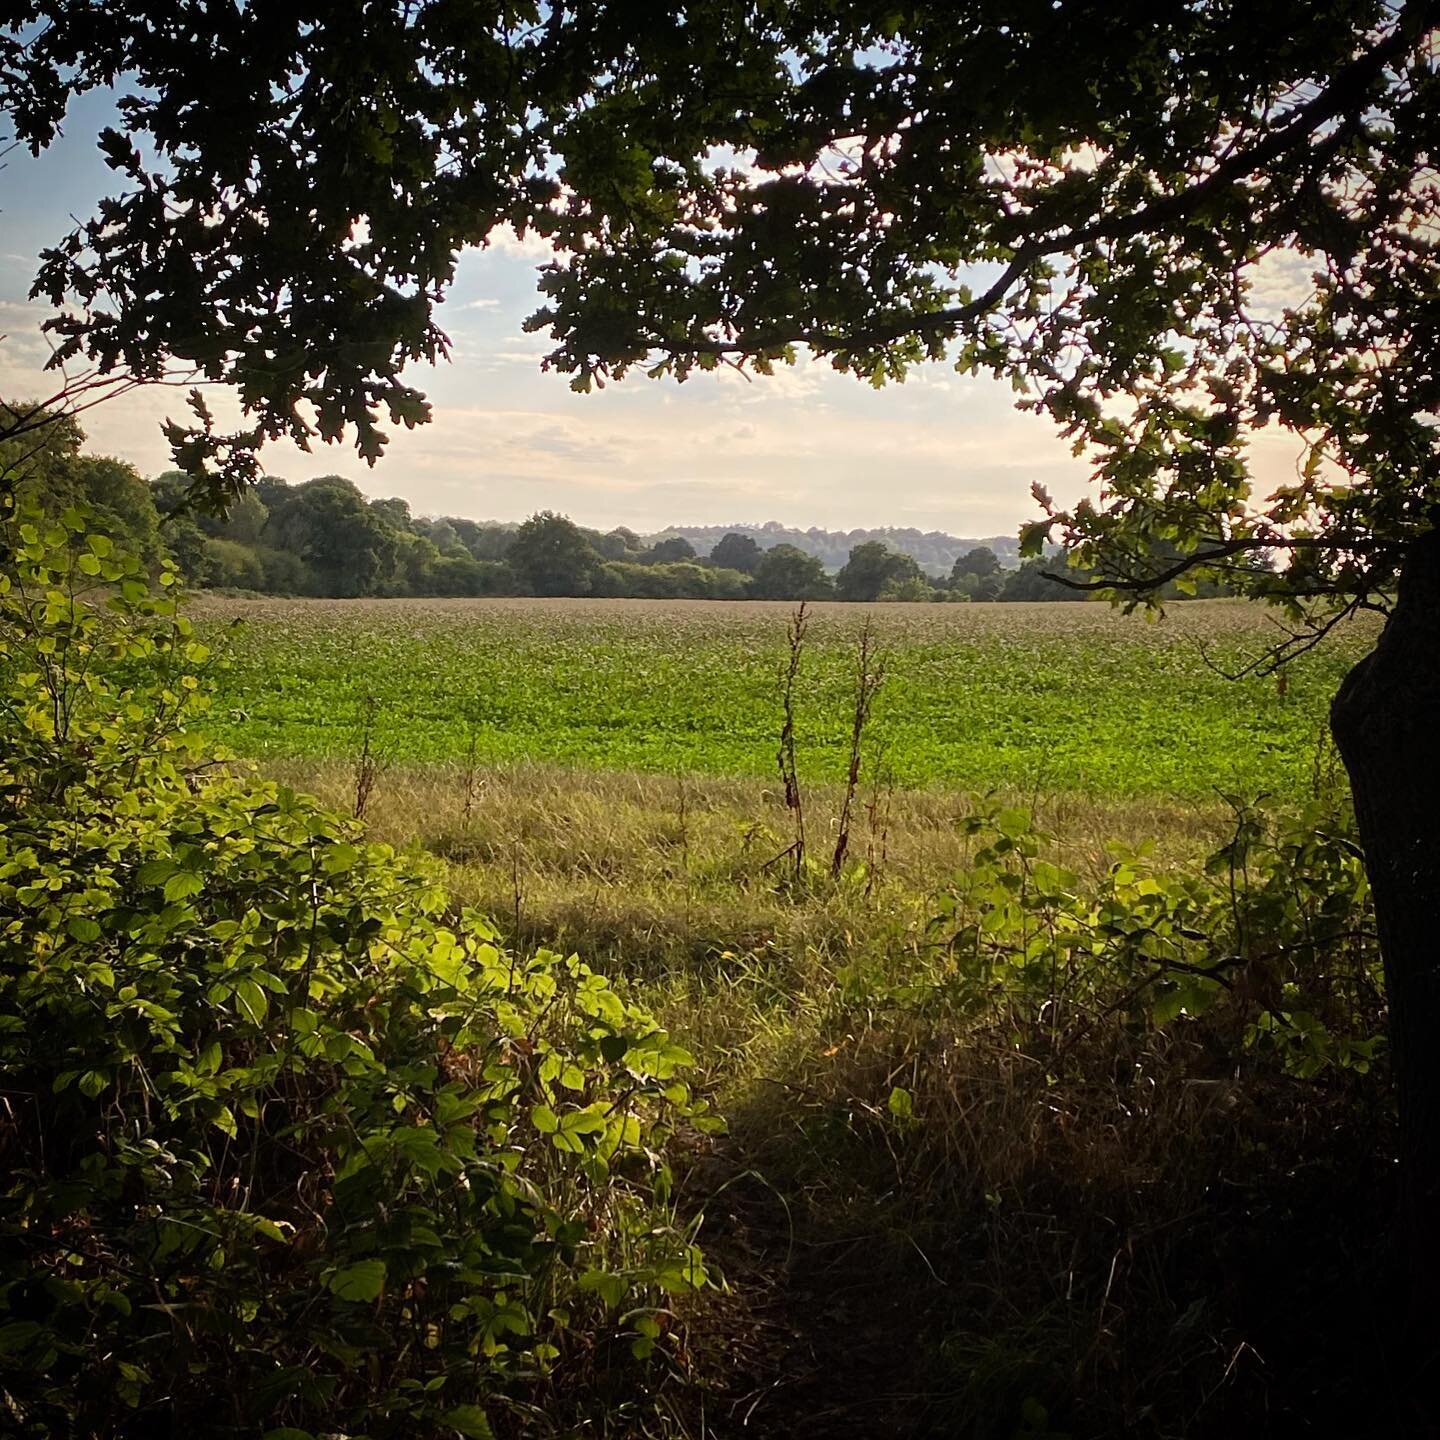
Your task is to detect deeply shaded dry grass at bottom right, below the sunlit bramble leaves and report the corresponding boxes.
[685,1037,1411,1440]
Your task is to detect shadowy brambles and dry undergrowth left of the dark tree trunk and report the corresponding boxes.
[691,792,1399,1437]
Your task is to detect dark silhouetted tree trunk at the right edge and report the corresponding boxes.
[1331,531,1440,1324]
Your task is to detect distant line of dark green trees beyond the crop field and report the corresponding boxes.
[8,425,1226,602]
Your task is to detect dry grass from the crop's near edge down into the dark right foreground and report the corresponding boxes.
[247,763,1405,1440]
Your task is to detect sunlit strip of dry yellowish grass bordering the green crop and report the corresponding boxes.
[266,762,1227,975]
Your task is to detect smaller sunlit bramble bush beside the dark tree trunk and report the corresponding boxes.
[937,800,1384,1077]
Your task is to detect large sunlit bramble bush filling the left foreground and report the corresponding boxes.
[0,511,717,1440]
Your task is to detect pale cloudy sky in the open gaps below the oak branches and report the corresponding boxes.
[0,95,1105,536]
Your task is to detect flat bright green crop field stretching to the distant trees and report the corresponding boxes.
[194,598,1371,798]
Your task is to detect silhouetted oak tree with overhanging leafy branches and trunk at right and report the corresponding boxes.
[8,0,1440,1284]
